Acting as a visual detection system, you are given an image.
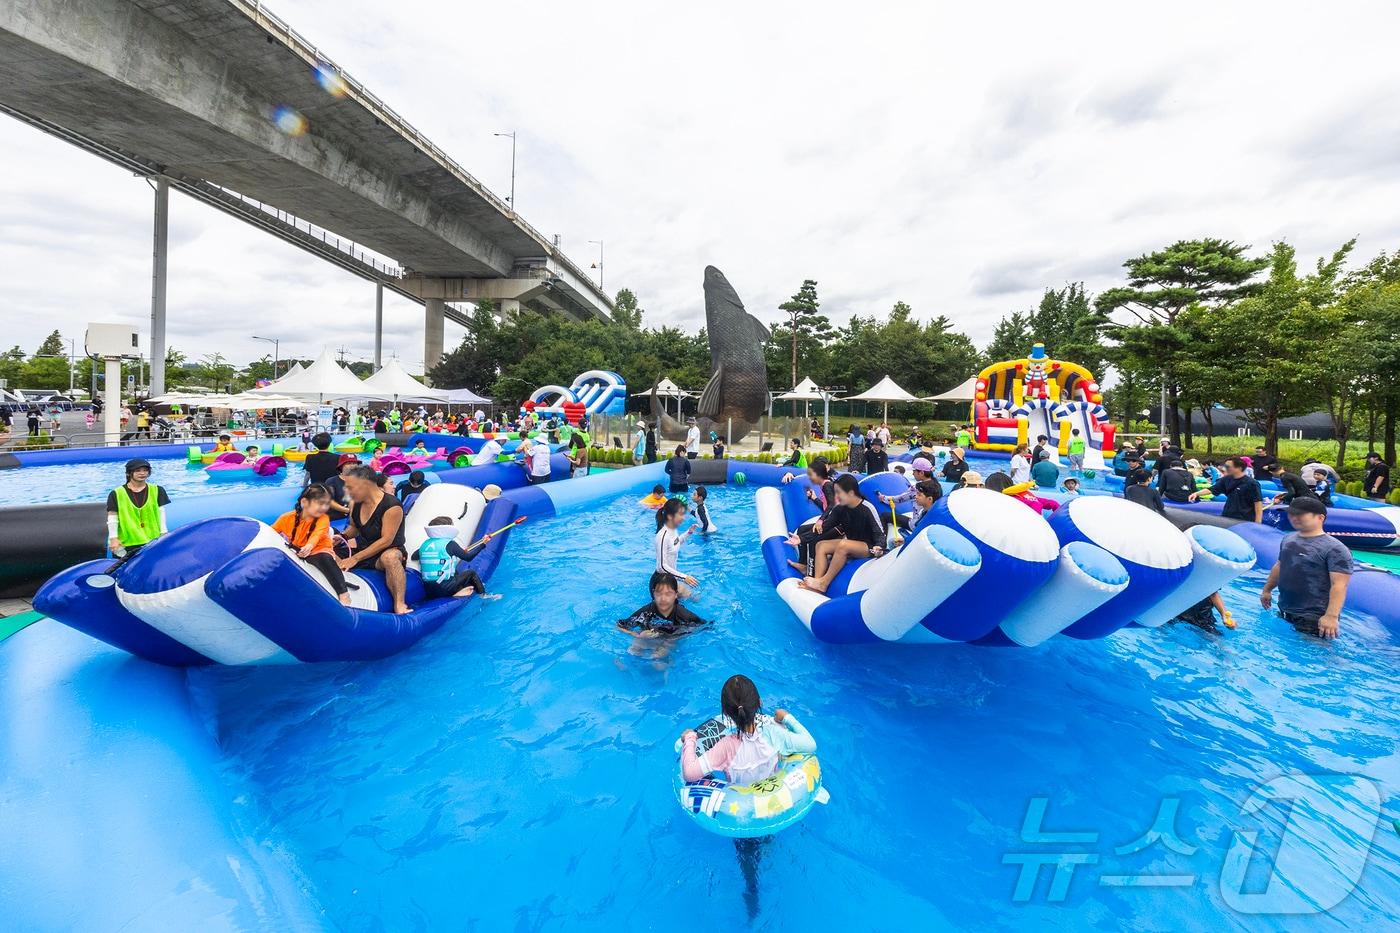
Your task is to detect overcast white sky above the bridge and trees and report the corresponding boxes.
[0,0,1400,378]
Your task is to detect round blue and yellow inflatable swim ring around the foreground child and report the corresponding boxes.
[675,719,829,838]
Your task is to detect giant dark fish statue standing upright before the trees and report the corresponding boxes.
[651,266,773,440]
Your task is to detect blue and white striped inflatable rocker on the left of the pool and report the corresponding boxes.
[34,483,515,667]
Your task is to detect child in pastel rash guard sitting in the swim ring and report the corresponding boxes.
[680,674,816,785]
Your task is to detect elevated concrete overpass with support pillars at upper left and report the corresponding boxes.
[0,0,612,389]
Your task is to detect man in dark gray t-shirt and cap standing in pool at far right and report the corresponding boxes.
[1259,496,1351,639]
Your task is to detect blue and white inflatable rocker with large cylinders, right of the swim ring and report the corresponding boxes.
[757,474,1256,647]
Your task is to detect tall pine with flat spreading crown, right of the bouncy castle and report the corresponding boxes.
[1095,238,1270,444]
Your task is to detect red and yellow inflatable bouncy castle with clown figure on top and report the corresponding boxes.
[972,343,1113,454]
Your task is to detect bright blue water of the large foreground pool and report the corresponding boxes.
[189,488,1400,930]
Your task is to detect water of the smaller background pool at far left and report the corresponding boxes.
[0,458,302,507]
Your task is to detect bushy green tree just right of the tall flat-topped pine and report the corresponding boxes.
[1204,240,1355,455]
